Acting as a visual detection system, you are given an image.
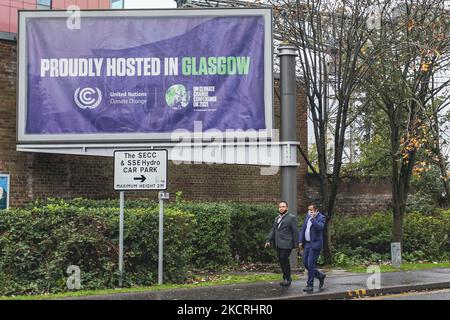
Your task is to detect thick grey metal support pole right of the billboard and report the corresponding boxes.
[278,44,298,268]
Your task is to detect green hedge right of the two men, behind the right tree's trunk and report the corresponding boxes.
[332,210,450,265]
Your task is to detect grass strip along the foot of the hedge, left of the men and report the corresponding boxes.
[0,273,299,300]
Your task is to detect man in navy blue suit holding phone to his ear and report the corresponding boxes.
[299,204,326,293]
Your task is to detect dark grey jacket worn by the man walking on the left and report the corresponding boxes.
[267,212,298,249]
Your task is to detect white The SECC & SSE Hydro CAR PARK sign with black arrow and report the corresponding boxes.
[114,150,168,191]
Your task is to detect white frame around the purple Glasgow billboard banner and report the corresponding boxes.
[16,7,274,145]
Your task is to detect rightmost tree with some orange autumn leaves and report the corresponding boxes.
[364,0,450,243]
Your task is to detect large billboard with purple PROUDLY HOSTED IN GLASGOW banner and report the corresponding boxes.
[17,8,273,143]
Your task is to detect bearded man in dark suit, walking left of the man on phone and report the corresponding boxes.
[264,201,299,287]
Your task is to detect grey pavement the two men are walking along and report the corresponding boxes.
[63,268,450,300]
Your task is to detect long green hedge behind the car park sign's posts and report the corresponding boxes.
[0,199,276,295]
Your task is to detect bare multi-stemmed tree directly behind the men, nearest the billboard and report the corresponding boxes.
[270,0,384,263]
